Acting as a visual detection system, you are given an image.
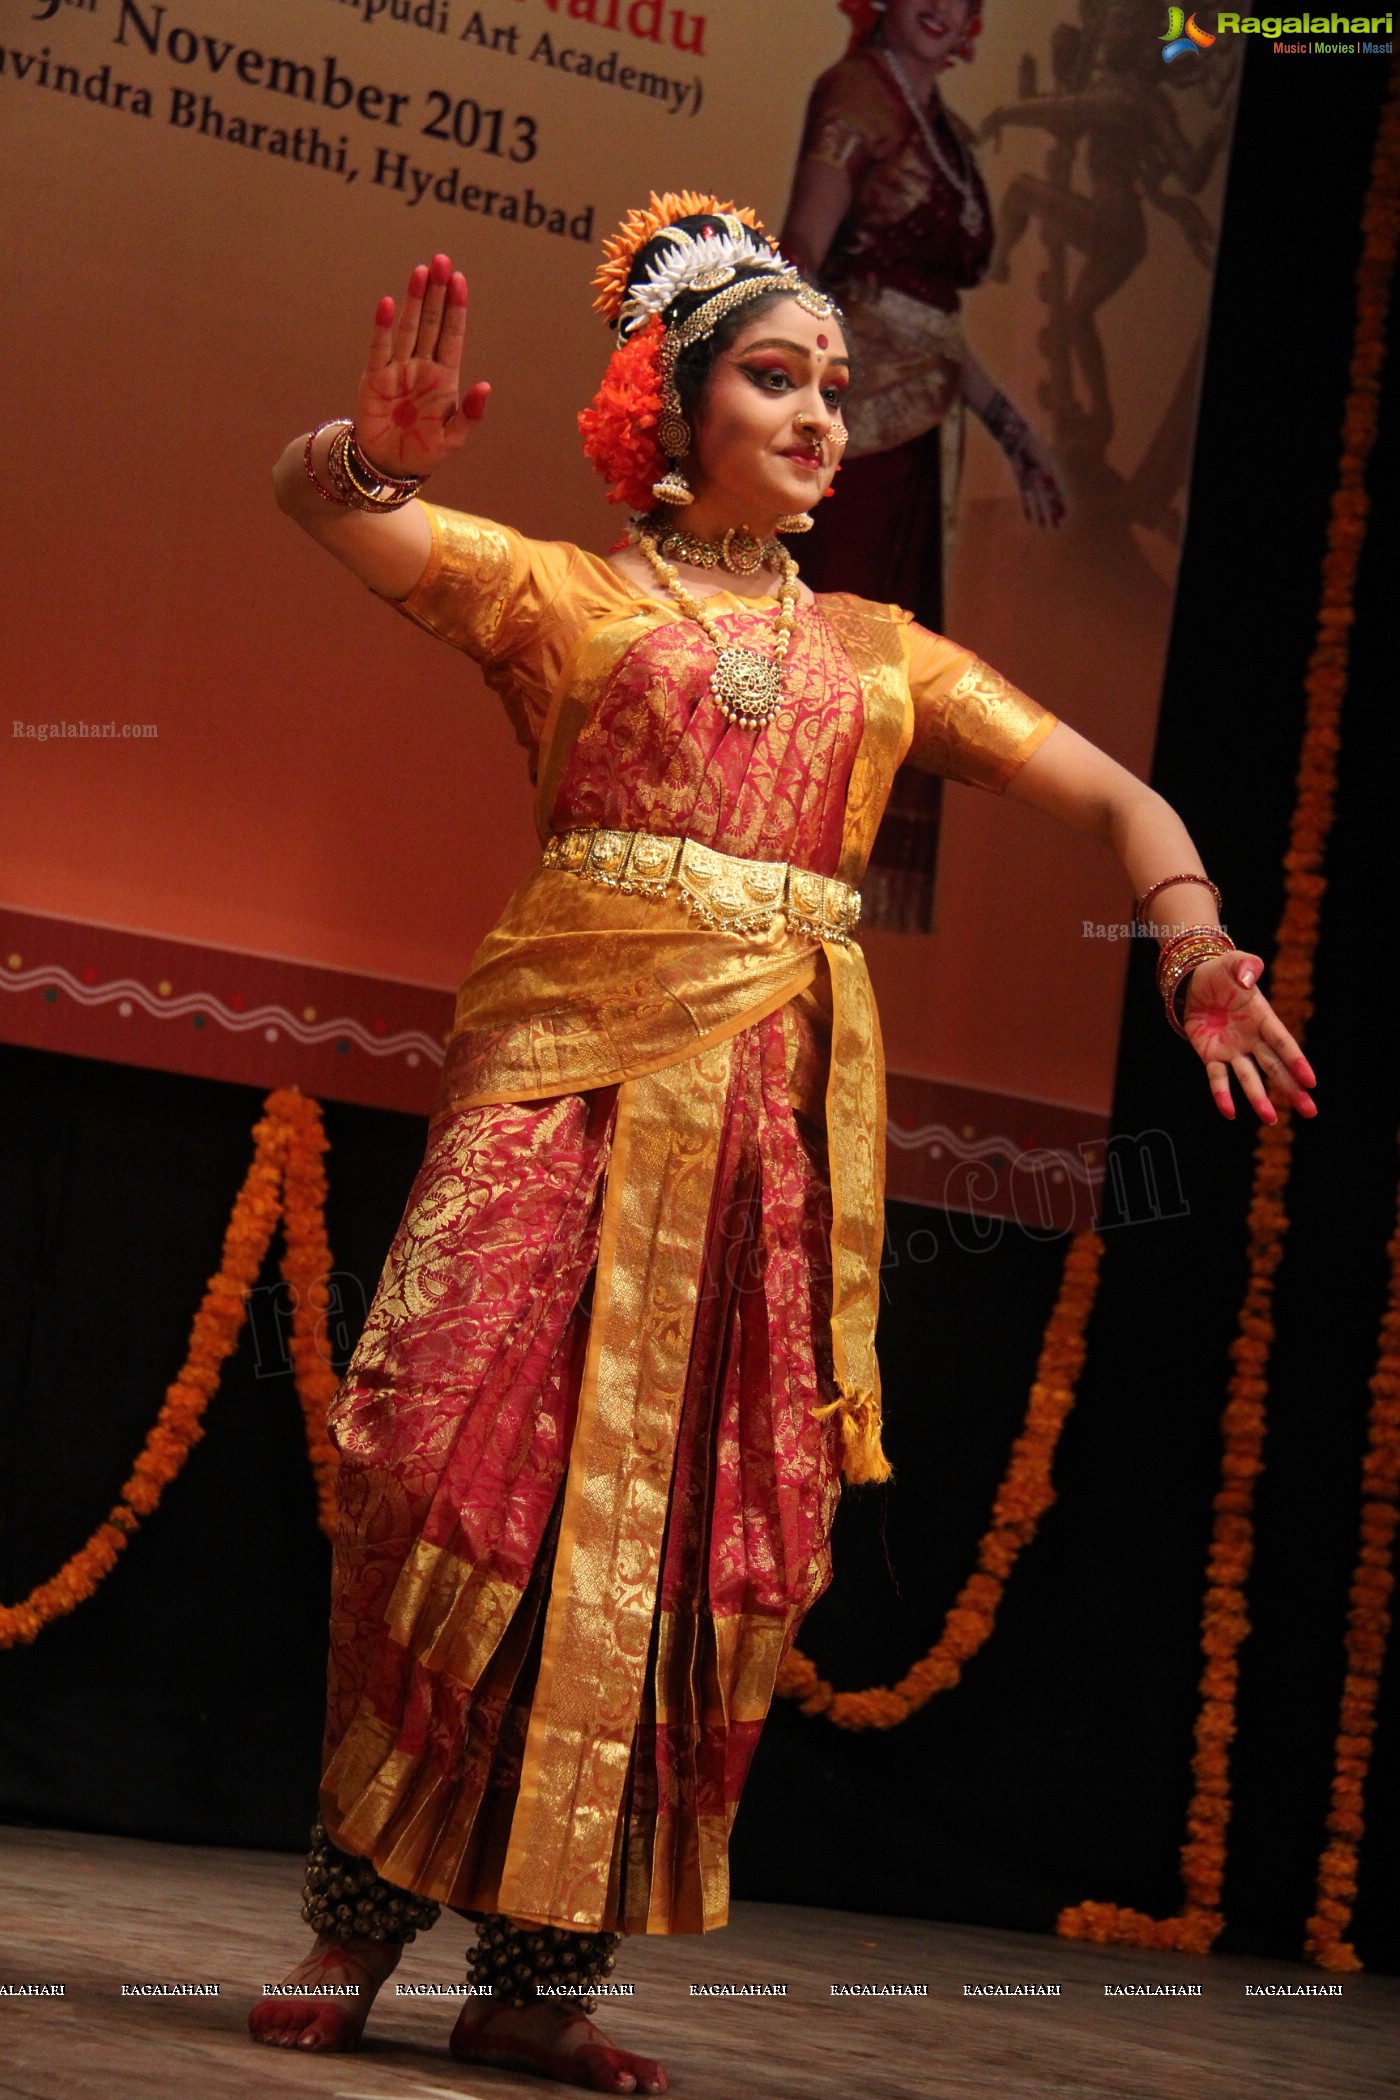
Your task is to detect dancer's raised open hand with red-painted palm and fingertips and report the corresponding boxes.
[355,254,491,477]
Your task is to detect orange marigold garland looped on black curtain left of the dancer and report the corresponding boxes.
[0,1088,336,1649]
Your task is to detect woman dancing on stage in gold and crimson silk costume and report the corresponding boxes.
[252,195,1312,2092]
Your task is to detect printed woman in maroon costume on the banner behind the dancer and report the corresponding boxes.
[783,0,1064,932]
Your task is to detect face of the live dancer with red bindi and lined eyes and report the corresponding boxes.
[686,298,850,529]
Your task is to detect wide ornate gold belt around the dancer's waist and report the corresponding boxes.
[544,827,861,943]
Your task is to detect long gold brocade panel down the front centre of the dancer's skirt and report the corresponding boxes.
[500,1044,730,1930]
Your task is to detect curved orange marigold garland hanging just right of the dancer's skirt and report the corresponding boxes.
[777,1233,1104,1728]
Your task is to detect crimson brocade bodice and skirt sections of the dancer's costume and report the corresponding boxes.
[323,601,863,1932]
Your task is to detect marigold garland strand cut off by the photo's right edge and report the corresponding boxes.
[1303,1167,1400,1970]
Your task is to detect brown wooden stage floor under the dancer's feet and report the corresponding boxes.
[0,1829,1400,2100]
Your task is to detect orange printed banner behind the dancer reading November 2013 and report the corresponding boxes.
[0,0,1238,1195]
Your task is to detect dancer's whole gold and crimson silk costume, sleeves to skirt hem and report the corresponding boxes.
[321,510,1054,1932]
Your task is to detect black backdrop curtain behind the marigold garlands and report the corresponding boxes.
[0,40,1400,1968]
